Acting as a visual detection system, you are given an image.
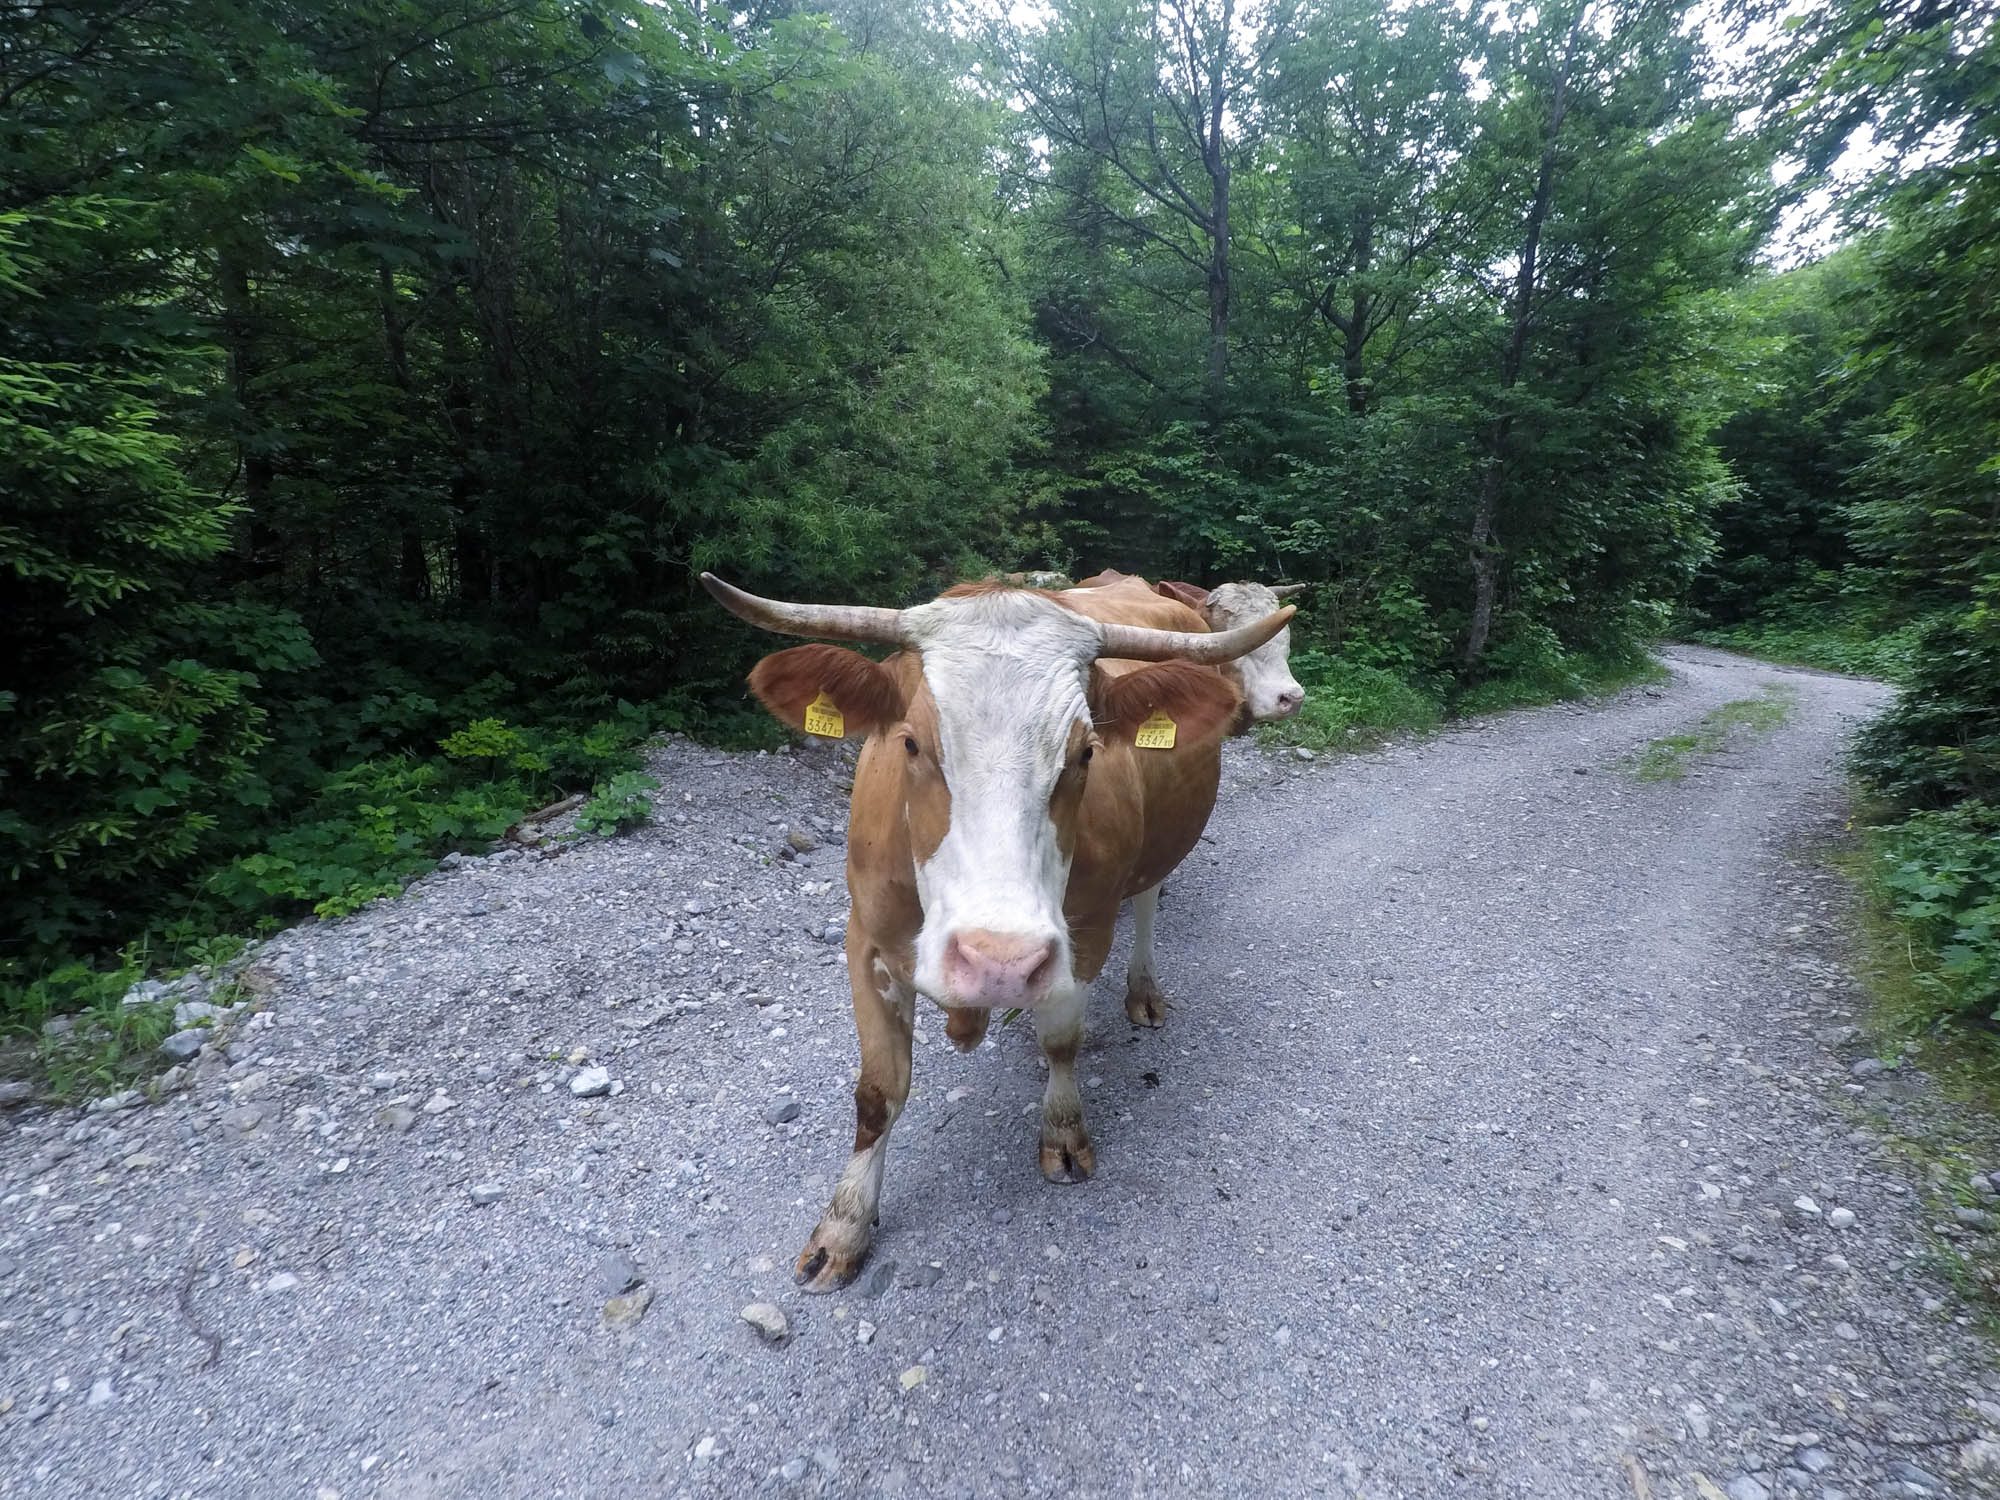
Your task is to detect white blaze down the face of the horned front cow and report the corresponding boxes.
[904,592,1100,1002]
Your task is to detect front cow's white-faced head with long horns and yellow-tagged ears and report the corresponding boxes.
[702,574,1292,1006]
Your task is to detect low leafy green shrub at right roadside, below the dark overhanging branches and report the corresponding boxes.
[1874,802,2000,1016]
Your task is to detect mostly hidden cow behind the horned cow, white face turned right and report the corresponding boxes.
[1062,568,1306,1026]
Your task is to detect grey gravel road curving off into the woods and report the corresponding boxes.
[0,648,2000,1500]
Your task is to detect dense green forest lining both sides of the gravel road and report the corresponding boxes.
[0,0,2000,1056]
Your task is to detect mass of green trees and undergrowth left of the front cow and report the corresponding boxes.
[0,0,1042,1004]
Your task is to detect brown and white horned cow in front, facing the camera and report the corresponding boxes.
[702,574,1292,1292]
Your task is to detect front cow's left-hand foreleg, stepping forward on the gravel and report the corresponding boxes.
[794,952,916,1292]
